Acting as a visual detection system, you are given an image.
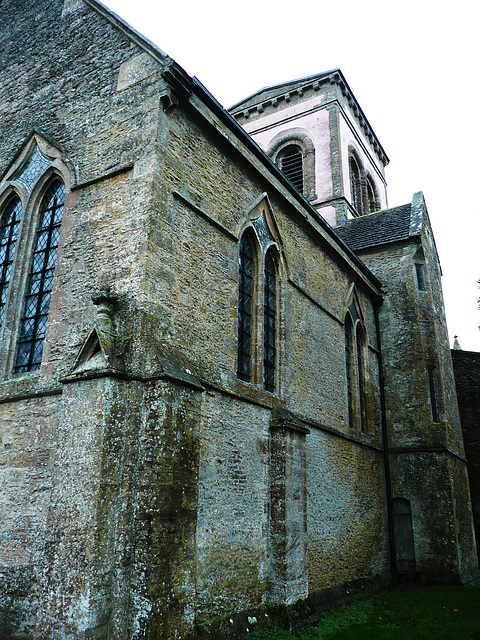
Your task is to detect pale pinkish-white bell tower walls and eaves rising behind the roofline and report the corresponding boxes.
[231,72,388,226]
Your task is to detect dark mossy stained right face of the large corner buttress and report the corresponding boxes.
[140,386,200,639]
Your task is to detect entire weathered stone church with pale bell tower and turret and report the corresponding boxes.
[0,0,478,640]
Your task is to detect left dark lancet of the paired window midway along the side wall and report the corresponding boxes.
[237,233,254,382]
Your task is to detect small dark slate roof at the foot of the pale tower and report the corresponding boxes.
[335,203,420,251]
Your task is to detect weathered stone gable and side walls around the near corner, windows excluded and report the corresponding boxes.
[0,0,469,640]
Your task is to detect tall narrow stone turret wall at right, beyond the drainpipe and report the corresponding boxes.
[359,202,477,582]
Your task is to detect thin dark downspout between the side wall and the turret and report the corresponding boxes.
[372,295,397,579]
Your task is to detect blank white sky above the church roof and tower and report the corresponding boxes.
[104,0,480,351]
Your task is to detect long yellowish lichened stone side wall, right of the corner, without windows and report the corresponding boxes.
[149,60,388,627]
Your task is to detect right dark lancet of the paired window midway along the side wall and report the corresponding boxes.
[263,250,277,391]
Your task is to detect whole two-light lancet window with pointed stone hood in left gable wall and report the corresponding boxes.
[0,134,68,376]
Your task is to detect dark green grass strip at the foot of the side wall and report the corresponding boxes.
[249,585,480,640]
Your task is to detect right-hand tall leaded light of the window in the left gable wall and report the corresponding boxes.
[14,178,65,373]
